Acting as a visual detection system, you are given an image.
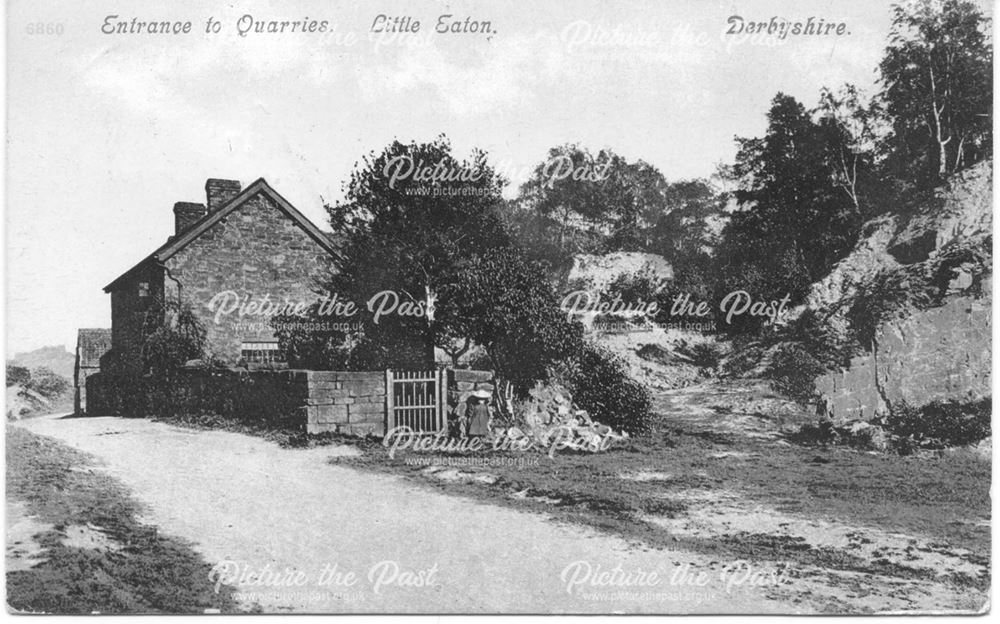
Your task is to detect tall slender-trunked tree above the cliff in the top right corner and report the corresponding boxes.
[879,0,993,185]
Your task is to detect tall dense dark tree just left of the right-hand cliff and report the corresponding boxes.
[718,93,860,332]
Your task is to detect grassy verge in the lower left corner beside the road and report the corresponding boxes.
[6,427,239,614]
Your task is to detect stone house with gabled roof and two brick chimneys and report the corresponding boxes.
[102,178,337,375]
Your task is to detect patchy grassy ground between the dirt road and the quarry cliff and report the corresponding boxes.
[335,408,990,574]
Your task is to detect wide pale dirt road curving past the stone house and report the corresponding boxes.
[11,417,801,613]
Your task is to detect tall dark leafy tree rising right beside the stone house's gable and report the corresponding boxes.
[320,136,509,368]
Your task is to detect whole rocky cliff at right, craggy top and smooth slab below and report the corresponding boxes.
[812,162,993,419]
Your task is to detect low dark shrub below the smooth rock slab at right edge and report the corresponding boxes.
[883,398,993,450]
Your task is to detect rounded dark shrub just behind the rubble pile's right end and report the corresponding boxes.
[567,344,652,435]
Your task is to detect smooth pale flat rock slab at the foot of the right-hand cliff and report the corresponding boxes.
[816,295,992,420]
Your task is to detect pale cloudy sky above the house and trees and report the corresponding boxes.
[6,0,960,354]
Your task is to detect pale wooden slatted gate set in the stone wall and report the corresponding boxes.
[385,369,448,431]
